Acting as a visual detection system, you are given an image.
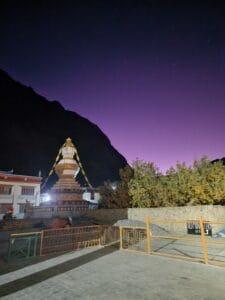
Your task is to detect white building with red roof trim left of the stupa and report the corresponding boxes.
[0,172,42,219]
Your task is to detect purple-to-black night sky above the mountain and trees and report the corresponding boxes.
[0,0,225,170]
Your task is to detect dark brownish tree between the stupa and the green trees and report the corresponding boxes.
[100,165,133,208]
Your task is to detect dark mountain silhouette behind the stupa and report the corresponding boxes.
[0,70,127,186]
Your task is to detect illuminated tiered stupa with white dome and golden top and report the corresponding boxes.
[50,138,88,206]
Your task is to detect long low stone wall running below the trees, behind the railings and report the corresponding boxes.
[25,205,225,233]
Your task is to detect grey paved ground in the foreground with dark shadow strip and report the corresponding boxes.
[0,247,225,300]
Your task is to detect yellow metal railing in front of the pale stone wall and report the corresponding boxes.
[120,217,225,266]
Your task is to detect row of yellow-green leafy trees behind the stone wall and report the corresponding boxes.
[129,157,225,207]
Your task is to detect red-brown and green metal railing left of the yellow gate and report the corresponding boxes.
[8,225,119,261]
